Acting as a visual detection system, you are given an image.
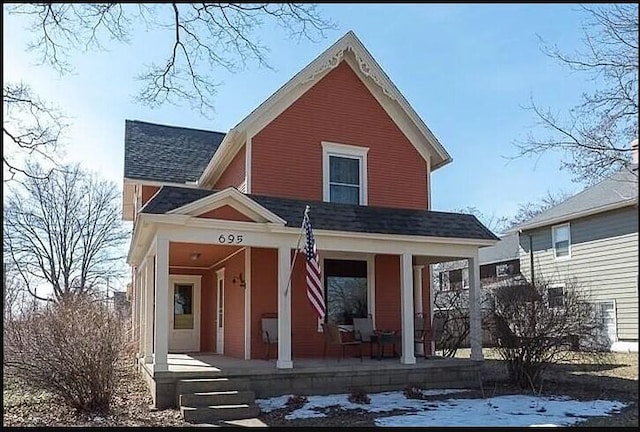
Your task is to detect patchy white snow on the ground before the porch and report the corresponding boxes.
[256,390,626,426]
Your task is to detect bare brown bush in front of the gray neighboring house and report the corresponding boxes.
[488,280,609,391]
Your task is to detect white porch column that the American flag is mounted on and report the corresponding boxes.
[276,247,293,369]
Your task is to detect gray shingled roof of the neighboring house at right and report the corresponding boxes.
[509,165,638,232]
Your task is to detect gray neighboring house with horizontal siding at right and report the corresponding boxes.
[508,164,638,352]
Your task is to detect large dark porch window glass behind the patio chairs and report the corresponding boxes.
[324,259,369,325]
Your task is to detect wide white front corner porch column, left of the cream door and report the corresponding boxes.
[153,238,169,372]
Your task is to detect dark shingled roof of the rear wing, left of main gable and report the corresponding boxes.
[124,120,225,183]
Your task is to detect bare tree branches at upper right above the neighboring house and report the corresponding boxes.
[516,3,638,184]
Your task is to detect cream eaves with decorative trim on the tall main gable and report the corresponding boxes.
[199,31,452,186]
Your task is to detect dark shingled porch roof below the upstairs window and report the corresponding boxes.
[141,186,498,240]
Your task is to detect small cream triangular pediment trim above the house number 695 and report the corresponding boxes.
[166,187,287,225]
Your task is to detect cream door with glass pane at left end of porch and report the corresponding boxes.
[169,275,200,352]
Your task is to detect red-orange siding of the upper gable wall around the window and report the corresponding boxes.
[251,63,427,209]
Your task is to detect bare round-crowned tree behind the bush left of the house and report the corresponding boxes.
[3,164,129,301]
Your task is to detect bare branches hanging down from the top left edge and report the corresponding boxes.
[8,3,335,115]
